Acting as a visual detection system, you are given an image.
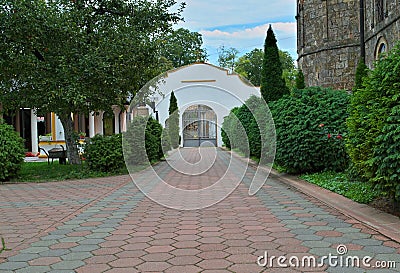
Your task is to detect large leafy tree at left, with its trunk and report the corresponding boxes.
[0,0,184,164]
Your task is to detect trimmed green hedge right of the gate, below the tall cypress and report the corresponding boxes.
[222,87,349,173]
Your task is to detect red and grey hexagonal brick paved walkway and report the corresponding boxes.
[0,149,400,273]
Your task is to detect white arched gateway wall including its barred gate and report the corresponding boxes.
[151,63,260,147]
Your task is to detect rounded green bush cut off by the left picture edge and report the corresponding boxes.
[0,119,25,181]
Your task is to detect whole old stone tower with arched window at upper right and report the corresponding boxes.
[296,0,400,90]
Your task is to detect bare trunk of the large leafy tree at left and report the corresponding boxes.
[59,114,81,165]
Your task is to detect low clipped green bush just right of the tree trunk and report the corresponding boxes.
[84,134,125,173]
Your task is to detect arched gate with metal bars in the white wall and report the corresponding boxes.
[182,104,217,147]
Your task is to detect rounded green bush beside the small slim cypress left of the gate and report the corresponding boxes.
[123,116,163,165]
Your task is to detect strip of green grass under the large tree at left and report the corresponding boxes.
[11,162,128,182]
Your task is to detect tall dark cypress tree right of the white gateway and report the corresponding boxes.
[261,25,289,103]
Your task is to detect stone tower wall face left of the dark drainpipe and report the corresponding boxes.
[297,0,360,89]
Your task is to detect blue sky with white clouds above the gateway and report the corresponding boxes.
[173,0,297,65]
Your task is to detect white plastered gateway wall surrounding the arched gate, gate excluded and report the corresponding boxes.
[150,63,260,146]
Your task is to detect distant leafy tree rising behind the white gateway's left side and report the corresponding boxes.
[161,28,207,68]
